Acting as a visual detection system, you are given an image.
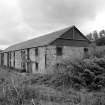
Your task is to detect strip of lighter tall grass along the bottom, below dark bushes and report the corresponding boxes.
[0,76,105,105]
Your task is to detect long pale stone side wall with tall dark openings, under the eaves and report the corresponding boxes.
[0,47,45,74]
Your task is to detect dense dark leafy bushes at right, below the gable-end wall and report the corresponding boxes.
[48,58,105,91]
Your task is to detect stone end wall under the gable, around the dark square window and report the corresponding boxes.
[46,46,84,72]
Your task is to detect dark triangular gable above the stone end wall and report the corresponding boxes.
[50,26,90,47]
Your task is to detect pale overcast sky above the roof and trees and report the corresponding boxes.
[0,0,105,49]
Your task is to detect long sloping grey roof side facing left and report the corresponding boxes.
[4,26,88,52]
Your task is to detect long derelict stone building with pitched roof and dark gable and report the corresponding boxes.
[0,26,90,73]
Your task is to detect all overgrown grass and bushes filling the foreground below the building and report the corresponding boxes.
[0,48,105,105]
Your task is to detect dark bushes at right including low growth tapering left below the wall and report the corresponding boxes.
[22,57,105,91]
